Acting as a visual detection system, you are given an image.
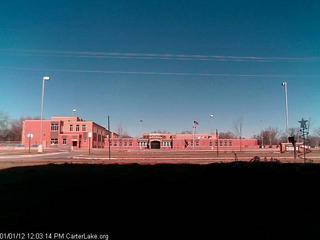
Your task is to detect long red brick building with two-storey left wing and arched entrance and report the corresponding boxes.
[22,117,259,150]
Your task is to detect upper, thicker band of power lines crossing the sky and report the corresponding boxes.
[0,49,320,62]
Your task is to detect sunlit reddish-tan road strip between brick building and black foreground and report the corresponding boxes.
[0,150,320,169]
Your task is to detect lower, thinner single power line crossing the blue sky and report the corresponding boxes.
[0,66,320,78]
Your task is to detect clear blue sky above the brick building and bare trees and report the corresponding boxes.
[0,0,320,136]
